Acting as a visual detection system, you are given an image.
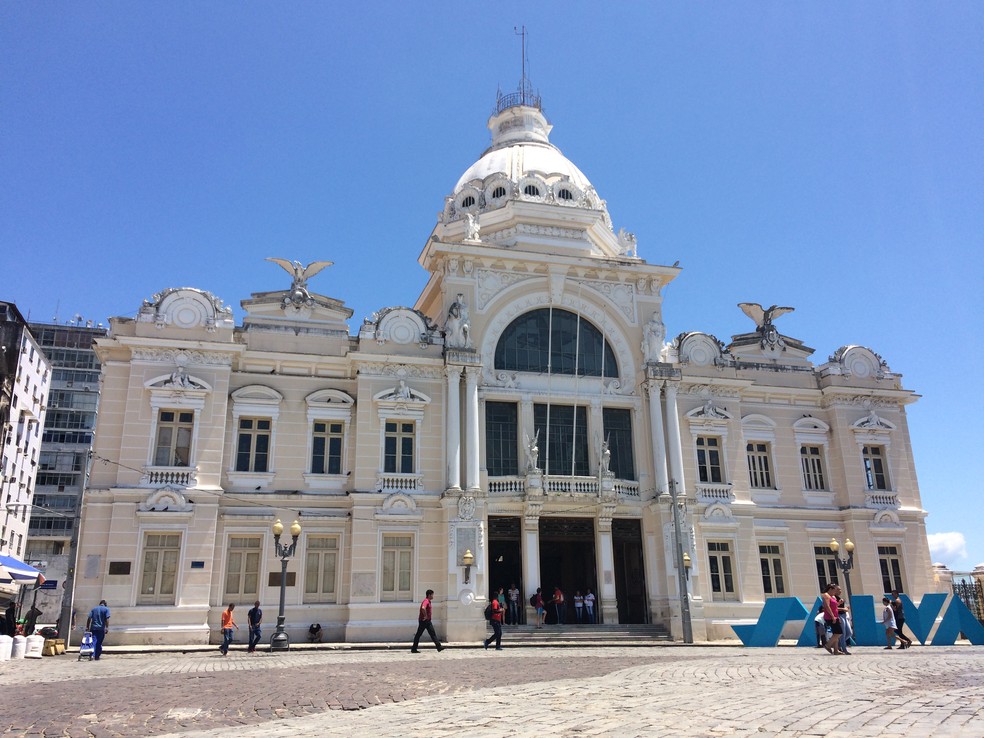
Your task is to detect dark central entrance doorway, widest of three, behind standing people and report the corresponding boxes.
[534,518,601,624]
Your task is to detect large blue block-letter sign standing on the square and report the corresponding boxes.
[731,594,984,648]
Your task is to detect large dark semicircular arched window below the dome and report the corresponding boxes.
[495,308,618,377]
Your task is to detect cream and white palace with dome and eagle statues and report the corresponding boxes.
[75,88,935,644]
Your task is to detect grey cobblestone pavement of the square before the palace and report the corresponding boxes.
[0,646,984,738]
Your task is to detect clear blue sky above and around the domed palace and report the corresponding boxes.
[0,1,984,570]
